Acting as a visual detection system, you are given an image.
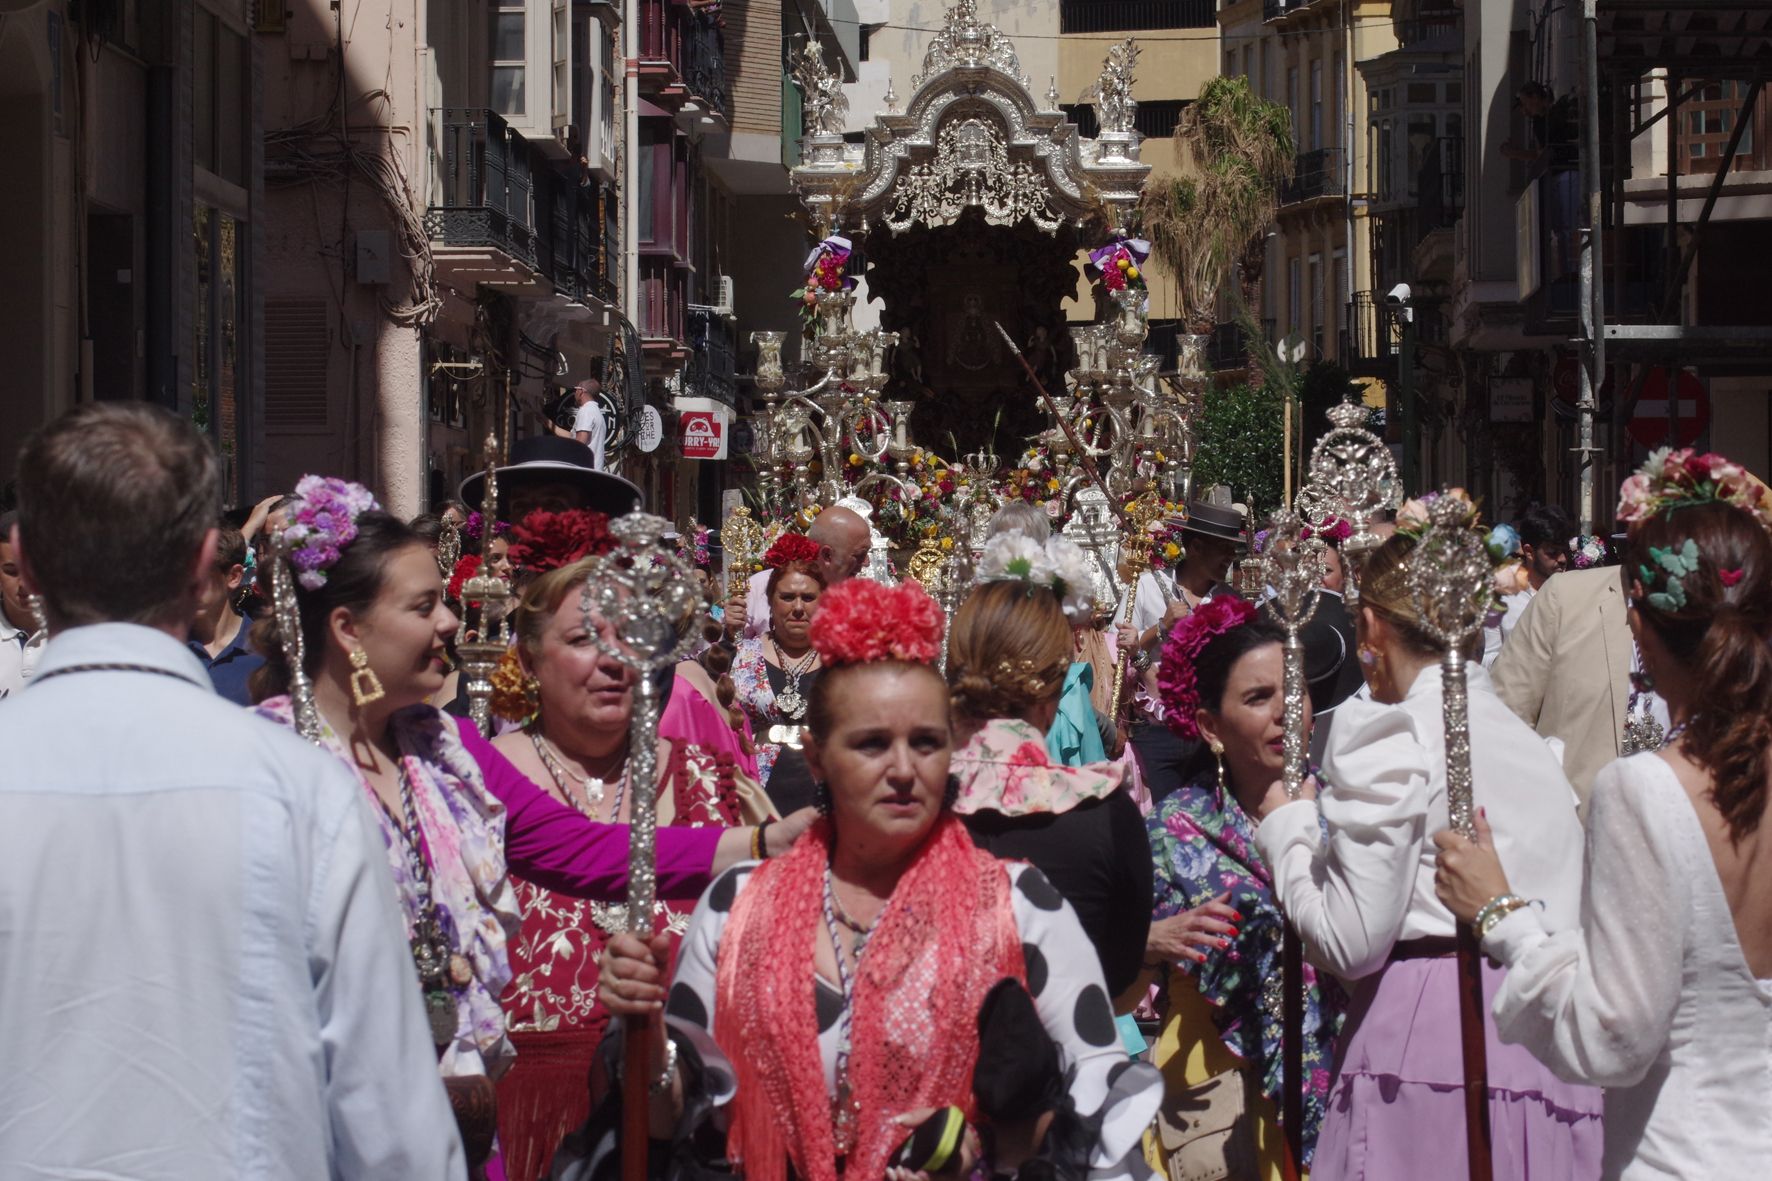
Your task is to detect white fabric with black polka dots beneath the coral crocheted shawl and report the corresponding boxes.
[665,862,1162,1181]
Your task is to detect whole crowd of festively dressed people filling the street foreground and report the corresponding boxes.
[0,399,1772,1181]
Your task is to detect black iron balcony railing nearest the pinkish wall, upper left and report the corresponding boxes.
[425,108,537,268]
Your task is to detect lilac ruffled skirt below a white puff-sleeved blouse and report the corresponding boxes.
[1311,956,1602,1181]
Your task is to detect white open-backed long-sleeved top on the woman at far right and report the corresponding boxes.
[1483,754,1772,1181]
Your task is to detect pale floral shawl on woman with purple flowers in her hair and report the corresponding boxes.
[259,697,523,1078]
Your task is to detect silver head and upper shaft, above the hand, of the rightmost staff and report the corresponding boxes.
[1405,489,1494,837]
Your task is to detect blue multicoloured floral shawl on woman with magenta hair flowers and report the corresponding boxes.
[1145,762,1347,1163]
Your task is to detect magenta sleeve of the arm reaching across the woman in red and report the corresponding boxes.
[459,722,727,903]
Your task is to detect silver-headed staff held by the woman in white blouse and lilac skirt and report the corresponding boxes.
[1258,509,1324,1167]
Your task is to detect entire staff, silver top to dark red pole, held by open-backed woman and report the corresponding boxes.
[1407,489,1494,1181]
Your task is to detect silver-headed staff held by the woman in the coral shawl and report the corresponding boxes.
[579,512,702,1181]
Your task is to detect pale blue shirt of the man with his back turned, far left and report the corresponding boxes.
[0,624,466,1181]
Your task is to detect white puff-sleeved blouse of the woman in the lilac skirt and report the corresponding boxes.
[1255,663,1582,981]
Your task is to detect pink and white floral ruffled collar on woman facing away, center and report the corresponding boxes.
[952,718,1125,816]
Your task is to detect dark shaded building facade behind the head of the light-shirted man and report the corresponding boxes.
[0,0,266,502]
